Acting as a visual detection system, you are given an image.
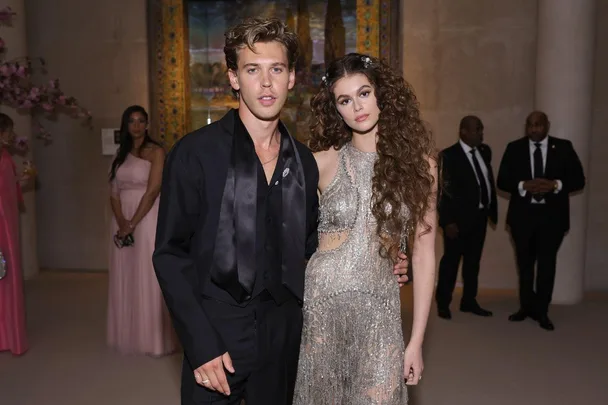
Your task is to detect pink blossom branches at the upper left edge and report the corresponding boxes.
[0,7,91,142]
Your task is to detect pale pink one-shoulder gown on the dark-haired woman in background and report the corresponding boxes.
[107,154,177,356]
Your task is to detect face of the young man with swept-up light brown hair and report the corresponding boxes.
[228,41,295,121]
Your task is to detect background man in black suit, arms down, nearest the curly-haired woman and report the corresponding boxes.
[435,115,497,319]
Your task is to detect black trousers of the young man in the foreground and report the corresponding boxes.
[181,293,302,405]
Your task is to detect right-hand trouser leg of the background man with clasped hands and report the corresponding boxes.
[536,226,564,316]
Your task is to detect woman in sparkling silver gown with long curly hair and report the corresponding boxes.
[294,54,437,405]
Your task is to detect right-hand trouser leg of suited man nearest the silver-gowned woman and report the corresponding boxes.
[461,211,488,305]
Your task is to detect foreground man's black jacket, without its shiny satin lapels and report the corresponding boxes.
[153,110,319,369]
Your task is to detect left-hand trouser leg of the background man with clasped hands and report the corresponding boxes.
[511,224,536,314]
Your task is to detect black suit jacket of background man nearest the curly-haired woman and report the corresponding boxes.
[438,142,498,230]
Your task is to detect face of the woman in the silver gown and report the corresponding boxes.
[334,73,380,134]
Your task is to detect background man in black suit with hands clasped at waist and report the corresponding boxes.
[498,111,585,330]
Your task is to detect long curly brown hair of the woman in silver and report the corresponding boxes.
[309,53,437,258]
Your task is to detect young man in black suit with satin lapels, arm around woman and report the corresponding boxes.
[153,19,407,405]
